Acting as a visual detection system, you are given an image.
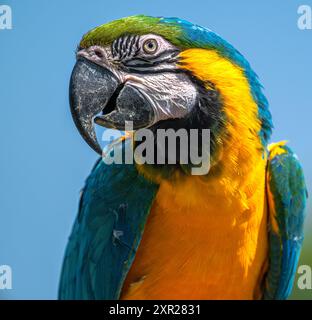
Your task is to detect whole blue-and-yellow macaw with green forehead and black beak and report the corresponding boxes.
[59,15,307,300]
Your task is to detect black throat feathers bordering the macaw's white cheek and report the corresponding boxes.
[136,74,226,178]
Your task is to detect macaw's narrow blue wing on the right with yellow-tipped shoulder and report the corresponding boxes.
[264,142,307,300]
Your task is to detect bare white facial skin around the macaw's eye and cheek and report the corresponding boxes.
[77,34,197,124]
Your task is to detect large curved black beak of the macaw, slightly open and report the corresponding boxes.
[69,57,155,154]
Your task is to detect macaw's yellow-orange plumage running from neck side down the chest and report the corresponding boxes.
[121,49,268,299]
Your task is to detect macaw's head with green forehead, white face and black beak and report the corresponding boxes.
[70,15,272,178]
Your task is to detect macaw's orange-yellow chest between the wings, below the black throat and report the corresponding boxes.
[121,160,268,299]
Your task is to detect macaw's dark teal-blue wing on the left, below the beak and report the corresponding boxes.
[59,144,158,300]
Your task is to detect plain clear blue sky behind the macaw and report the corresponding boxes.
[0,0,312,299]
